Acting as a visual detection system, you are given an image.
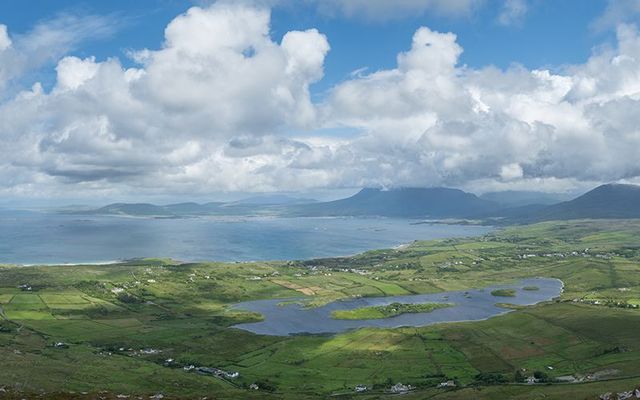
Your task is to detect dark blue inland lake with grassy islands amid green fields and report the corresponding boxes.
[235,278,563,336]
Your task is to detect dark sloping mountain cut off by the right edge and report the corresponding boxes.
[513,184,640,222]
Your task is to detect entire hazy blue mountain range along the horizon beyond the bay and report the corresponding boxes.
[74,184,640,224]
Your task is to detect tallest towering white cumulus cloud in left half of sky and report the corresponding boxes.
[0,4,329,197]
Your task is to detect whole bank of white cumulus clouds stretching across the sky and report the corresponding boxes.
[0,3,640,196]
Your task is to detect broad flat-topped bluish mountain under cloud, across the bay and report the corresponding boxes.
[288,188,500,218]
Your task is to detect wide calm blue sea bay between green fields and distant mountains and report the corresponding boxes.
[0,211,491,264]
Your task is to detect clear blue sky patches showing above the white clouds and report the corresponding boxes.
[0,0,614,95]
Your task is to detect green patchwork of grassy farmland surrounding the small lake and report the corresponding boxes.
[0,220,640,399]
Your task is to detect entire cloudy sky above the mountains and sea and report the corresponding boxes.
[0,0,640,205]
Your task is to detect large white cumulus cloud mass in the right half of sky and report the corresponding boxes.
[324,25,640,192]
